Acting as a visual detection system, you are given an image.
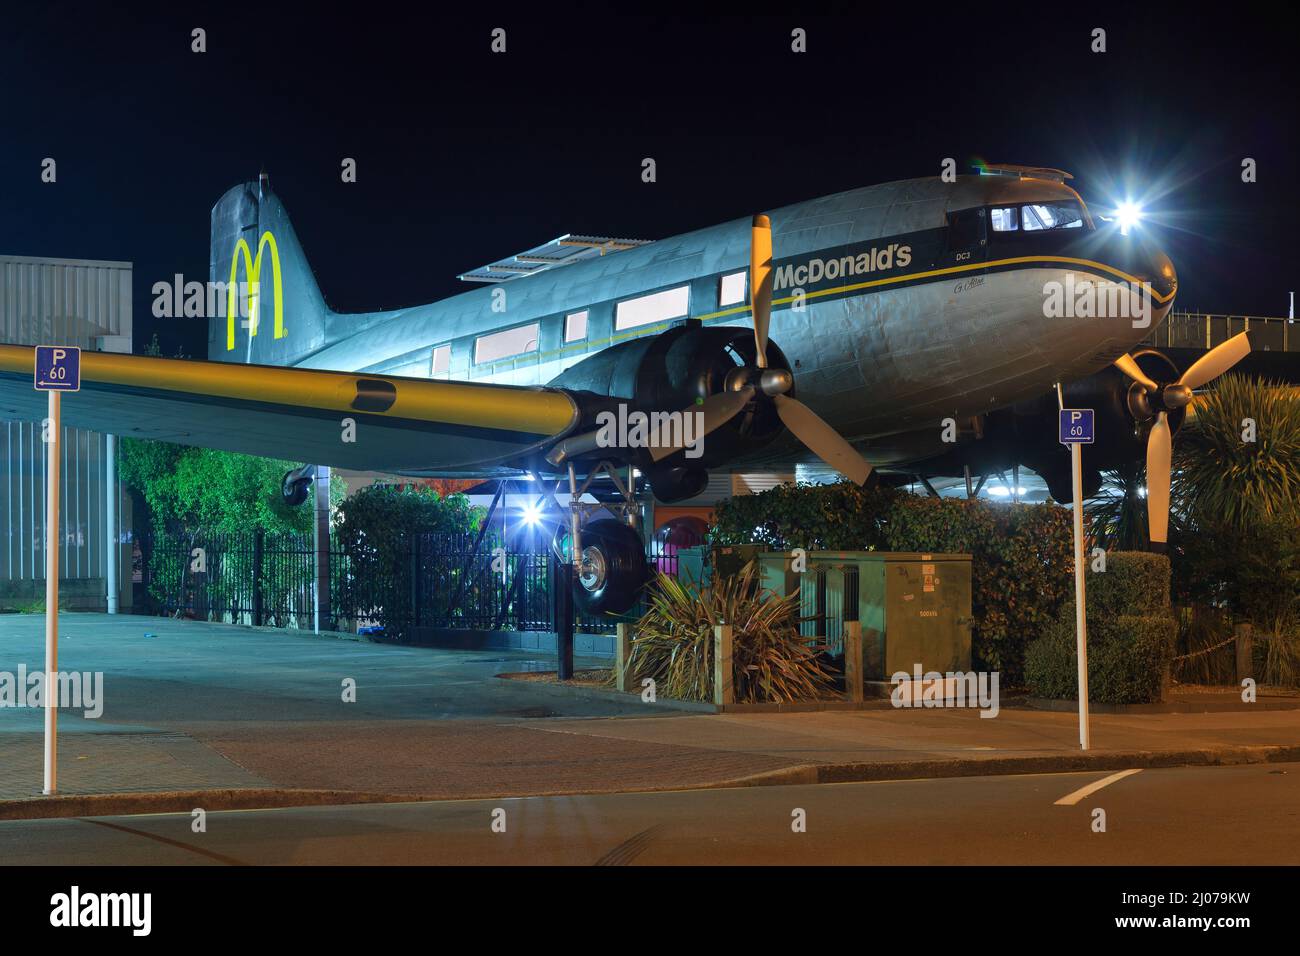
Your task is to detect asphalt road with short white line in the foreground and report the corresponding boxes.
[0,763,1300,866]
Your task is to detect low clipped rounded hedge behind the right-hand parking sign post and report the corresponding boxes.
[1024,551,1178,704]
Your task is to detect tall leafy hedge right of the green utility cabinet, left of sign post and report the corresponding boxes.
[888,496,1074,685]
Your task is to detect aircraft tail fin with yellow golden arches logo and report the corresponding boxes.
[208,173,329,365]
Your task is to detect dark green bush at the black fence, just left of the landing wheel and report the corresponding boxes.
[335,485,484,641]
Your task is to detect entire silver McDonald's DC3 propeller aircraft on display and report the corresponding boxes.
[0,166,1249,611]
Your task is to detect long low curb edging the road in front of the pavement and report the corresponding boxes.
[0,745,1300,821]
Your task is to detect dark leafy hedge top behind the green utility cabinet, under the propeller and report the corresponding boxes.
[710,481,898,551]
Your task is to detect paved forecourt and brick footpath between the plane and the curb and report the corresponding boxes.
[0,614,1300,817]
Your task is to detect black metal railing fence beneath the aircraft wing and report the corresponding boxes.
[140,531,677,633]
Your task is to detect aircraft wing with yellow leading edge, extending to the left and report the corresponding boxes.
[0,345,580,475]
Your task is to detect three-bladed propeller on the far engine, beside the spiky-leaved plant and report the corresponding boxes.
[1115,332,1251,550]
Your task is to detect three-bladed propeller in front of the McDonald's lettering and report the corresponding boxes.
[650,215,871,485]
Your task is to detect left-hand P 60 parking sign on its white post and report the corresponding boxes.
[34,345,81,796]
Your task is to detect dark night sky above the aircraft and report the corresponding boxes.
[0,3,1300,356]
